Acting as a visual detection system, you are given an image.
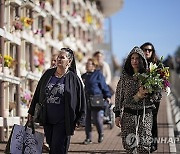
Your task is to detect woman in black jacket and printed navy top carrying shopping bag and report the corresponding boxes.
[28,48,86,154]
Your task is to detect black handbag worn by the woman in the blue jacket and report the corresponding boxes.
[89,95,105,108]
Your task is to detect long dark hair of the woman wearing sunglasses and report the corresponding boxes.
[140,42,158,64]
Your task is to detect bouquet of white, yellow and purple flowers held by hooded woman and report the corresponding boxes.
[135,57,171,96]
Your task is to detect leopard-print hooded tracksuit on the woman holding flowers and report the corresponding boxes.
[114,47,159,151]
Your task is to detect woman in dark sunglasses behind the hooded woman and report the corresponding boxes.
[140,42,162,152]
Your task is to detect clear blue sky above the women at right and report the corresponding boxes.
[106,0,180,63]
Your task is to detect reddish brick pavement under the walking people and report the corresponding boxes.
[0,93,180,154]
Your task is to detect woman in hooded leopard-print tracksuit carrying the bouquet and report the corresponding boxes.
[113,47,158,154]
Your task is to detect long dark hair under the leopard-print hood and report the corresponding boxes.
[124,52,146,76]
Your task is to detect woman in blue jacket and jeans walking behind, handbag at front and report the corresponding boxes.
[82,58,111,144]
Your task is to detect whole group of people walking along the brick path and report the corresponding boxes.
[28,42,165,154]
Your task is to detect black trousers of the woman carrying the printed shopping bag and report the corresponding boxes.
[44,122,70,154]
